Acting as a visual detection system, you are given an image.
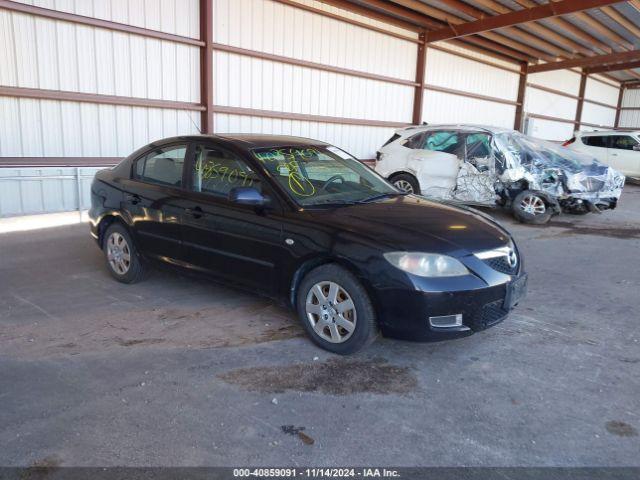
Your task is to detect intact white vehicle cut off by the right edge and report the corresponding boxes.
[563,131,640,180]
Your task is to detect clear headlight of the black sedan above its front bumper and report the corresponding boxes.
[384,252,469,277]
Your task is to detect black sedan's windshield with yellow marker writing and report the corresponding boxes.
[253,146,402,206]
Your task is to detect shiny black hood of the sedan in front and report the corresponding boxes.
[304,195,510,257]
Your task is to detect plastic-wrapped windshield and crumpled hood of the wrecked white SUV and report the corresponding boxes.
[495,132,598,172]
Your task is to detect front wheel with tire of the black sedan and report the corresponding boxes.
[296,264,377,355]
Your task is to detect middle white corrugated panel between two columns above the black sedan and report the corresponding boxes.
[213,52,414,122]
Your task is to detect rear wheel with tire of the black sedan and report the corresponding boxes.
[103,223,147,283]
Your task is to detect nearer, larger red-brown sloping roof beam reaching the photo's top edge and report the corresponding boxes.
[427,0,620,42]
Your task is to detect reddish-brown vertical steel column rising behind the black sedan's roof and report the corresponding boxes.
[200,0,213,133]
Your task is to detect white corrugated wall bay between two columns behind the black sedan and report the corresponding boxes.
[213,0,417,158]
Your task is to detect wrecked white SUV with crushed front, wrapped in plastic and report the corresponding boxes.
[375,125,625,224]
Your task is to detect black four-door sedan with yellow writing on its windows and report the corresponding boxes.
[90,135,527,354]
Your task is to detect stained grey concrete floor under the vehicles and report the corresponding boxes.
[0,186,640,466]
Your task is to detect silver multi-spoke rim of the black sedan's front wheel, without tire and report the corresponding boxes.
[305,281,357,343]
